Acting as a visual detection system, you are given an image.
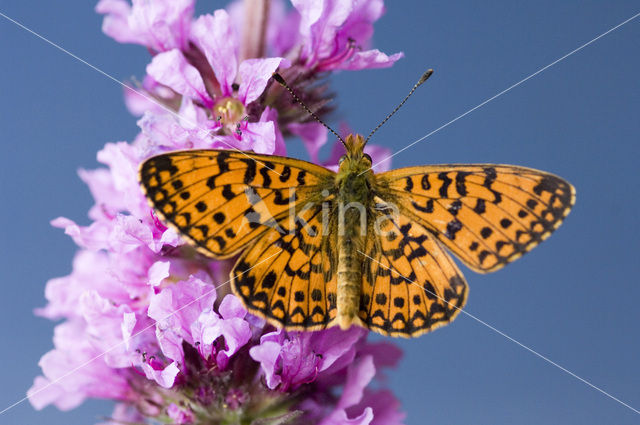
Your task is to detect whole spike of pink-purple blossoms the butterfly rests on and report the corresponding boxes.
[28,0,403,425]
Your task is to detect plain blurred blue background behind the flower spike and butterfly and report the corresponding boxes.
[0,0,640,425]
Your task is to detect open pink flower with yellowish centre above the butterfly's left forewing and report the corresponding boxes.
[141,10,288,153]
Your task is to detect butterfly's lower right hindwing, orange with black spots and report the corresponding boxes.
[359,210,467,337]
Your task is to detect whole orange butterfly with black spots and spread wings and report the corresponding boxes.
[139,131,575,337]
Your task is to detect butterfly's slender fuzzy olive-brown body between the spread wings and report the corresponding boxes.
[336,135,374,329]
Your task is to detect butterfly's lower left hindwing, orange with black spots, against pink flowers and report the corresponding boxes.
[231,202,337,331]
